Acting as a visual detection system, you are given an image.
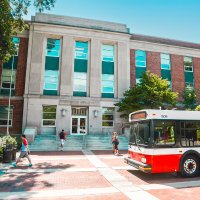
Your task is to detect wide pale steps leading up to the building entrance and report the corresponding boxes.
[29,134,128,151]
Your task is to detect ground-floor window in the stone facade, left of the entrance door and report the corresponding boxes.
[42,106,56,127]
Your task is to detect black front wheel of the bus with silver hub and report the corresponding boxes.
[181,155,200,178]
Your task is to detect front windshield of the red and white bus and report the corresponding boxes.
[130,121,150,146]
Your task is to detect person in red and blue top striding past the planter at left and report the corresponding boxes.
[13,134,32,167]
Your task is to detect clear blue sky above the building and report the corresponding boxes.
[25,0,200,43]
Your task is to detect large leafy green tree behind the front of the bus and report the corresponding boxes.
[115,71,178,117]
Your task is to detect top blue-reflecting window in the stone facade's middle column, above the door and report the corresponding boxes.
[75,41,88,60]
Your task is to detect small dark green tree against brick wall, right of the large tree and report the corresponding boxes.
[183,88,197,110]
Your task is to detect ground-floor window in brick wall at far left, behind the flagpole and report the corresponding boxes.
[0,106,13,127]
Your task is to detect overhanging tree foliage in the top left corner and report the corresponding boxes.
[0,0,56,63]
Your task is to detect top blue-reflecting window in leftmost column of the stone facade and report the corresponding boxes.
[46,38,60,57]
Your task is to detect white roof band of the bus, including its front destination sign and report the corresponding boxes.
[129,109,200,122]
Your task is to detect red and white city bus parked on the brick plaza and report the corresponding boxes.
[124,109,200,177]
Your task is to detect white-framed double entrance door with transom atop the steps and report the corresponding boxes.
[71,107,87,134]
